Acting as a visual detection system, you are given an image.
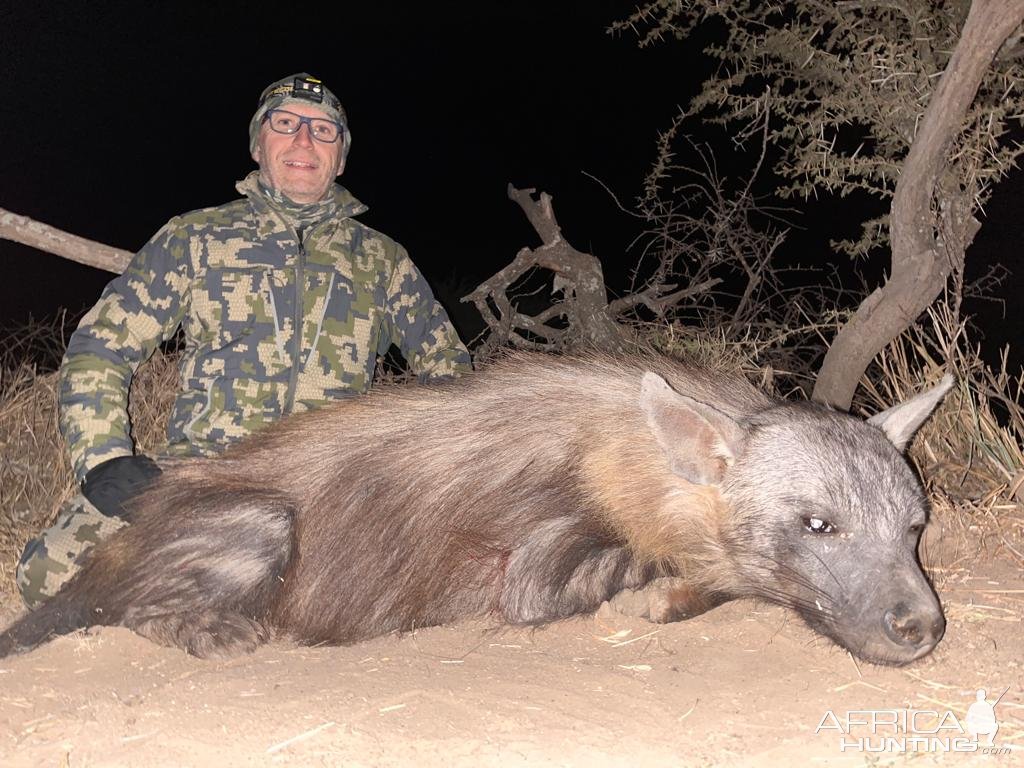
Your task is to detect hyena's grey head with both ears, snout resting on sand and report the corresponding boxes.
[641,374,952,665]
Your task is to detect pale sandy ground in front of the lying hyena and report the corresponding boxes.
[0,524,1024,768]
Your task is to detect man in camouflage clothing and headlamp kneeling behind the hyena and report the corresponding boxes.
[17,73,470,606]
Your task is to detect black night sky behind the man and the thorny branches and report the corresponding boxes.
[0,0,1024,370]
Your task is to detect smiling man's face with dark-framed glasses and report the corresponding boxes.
[253,103,344,203]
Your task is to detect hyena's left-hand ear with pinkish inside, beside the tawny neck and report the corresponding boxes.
[640,372,745,485]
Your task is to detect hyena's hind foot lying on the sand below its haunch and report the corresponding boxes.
[126,610,270,658]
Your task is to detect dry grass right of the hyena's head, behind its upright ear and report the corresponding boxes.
[854,303,1024,565]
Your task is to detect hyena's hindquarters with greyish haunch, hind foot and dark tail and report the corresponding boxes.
[0,481,296,658]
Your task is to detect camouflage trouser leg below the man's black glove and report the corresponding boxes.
[15,494,126,608]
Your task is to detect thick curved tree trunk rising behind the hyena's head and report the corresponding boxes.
[812,0,1024,411]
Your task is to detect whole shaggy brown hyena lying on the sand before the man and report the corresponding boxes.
[0,354,951,664]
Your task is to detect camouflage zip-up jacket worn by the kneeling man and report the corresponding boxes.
[66,172,469,479]
